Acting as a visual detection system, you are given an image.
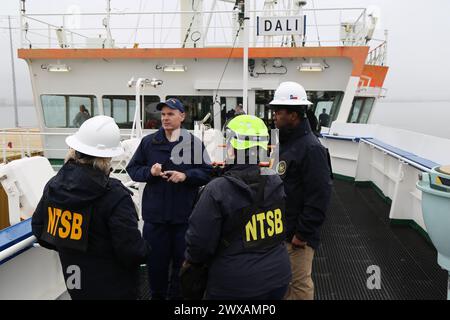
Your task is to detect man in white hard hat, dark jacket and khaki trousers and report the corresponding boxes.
[270,82,331,300]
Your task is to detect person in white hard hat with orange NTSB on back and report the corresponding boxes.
[32,116,150,299]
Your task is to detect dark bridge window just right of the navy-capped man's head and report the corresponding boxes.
[166,95,214,130]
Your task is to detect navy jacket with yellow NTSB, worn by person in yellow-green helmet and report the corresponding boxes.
[186,165,291,299]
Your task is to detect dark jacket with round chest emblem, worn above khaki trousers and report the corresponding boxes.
[275,121,332,249]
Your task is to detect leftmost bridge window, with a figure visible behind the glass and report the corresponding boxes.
[41,95,99,128]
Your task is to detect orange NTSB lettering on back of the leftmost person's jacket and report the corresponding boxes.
[47,207,83,240]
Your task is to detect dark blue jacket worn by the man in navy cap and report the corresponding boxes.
[127,128,212,224]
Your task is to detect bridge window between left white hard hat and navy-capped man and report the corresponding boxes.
[102,95,161,129]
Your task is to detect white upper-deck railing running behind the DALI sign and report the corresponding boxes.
[16,8,379,49]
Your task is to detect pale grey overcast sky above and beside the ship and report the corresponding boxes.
[0,0,450,106]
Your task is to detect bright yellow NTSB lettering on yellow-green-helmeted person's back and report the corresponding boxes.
[245,209,284,242]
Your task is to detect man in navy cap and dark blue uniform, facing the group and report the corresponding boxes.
[127,98,212,300]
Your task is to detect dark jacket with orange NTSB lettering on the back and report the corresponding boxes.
[31,161,150,299]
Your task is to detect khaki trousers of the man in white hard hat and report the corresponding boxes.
[284,243,314,300]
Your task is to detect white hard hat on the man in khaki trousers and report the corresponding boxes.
[269,81,312,106]
